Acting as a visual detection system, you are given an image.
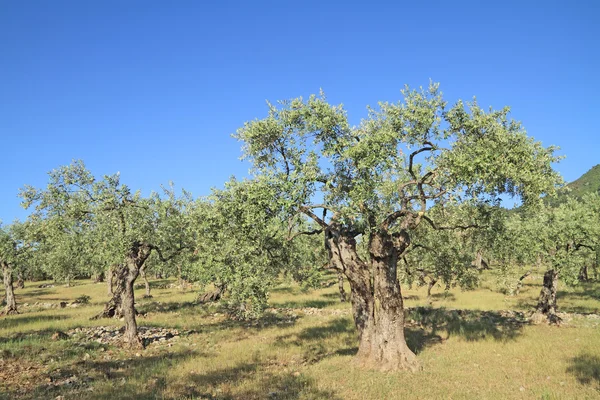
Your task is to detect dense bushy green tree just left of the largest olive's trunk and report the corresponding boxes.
[189,179,295,318]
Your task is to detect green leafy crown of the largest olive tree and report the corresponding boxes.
[234,83,562,294]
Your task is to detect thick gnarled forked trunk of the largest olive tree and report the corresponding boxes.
[325,225,420,371]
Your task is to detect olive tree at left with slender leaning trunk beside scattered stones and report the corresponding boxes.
[20,161,188,347]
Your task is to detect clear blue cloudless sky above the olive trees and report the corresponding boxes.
[0,0,600,222]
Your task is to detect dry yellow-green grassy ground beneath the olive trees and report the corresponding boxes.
[0,273,600,400]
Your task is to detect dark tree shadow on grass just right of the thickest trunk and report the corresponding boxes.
[407,307,529,341]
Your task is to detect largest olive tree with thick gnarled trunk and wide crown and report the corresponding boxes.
[235,84,559,370]
